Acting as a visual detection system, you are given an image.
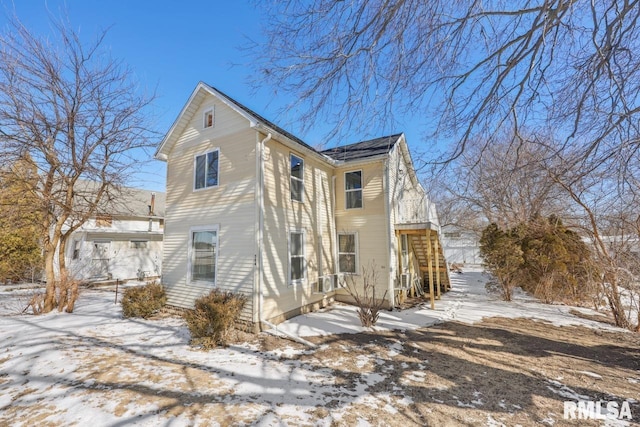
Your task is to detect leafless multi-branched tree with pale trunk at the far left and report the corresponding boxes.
[0,18,152,312]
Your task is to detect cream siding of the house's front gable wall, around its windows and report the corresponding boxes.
[163,97,256,320]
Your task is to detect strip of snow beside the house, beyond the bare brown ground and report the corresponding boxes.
[277,268,619,337]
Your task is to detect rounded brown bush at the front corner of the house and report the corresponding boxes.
[183,289,247,350]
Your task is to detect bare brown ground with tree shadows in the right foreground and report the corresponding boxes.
[305,318,640,426]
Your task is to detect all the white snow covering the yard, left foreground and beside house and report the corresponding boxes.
[0,270,631,426]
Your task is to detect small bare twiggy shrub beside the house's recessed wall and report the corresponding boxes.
[346,264,387,328]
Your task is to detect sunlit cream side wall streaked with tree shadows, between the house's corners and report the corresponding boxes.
[263,140,336,319]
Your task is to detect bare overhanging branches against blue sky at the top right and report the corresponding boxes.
[255,0,640,169]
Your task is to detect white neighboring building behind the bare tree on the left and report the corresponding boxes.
[66,188,165,281]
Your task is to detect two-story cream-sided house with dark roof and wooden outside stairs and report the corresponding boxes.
[156,83,448,326]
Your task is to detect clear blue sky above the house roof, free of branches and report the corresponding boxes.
[0,0,430,191]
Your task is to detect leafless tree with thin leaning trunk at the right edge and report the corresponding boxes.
[548,152,640,331]
